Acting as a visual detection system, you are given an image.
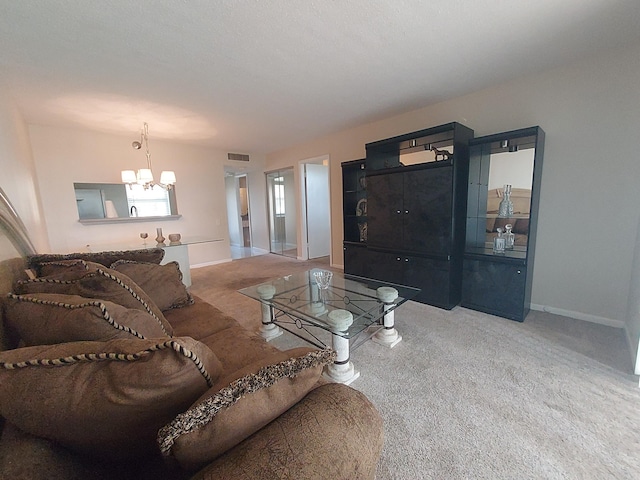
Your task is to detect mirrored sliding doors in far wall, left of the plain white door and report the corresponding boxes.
[266,167,298,258]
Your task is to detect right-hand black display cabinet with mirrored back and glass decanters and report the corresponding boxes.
[461,127,545,321]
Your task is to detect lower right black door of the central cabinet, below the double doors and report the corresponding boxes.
[403,257,459,309]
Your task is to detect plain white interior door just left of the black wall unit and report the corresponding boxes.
[305,163,331,259]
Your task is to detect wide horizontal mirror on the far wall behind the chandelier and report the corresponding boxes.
[73,183,178,221]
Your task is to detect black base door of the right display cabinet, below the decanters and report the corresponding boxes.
[462,259,529,322]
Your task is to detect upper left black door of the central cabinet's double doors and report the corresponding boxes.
[367,173,404,249]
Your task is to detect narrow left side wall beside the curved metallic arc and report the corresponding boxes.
[0,85,49,250]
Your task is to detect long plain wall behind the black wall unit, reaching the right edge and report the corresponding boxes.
[267,45,640,326]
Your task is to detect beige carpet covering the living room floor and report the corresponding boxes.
[192,255,640,480]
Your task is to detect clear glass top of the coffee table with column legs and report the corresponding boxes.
[239,269,420,338]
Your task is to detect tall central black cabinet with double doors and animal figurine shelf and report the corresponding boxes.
[343,123,473,309]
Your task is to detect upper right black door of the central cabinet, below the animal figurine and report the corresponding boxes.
[403,166,453,255]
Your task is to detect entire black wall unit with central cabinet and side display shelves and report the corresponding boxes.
[342,122,544,321]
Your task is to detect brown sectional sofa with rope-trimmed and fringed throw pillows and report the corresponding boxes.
[0,249,383,479]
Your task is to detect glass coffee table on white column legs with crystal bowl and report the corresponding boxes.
[239,269,420,385]
